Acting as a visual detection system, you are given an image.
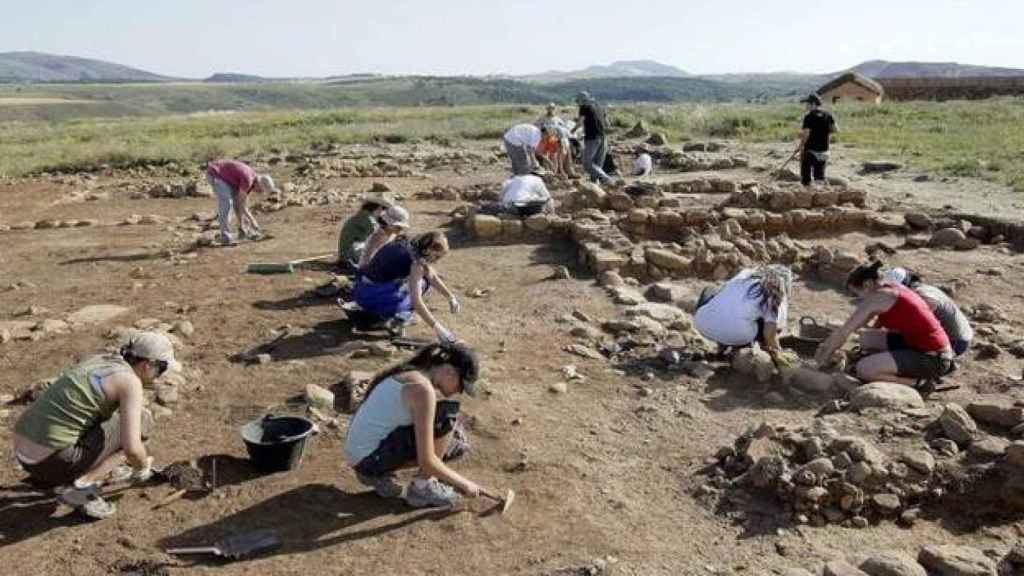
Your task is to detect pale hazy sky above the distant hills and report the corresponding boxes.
[0,0,1024,78]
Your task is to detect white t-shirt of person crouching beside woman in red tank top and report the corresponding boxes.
[693,270,788,346]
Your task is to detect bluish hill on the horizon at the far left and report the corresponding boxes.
[0,52,172,82]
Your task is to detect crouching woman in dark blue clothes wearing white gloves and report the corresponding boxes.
[352,232,462,342]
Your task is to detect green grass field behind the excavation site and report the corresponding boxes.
[0,84,1024,192]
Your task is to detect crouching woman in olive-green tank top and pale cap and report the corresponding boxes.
[14,332,177,519]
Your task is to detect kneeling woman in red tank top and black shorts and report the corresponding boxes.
[815,261,955,394]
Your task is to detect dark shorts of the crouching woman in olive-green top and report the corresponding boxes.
[22,409,153,486]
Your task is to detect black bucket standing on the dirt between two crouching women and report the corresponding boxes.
[242,414,313,472]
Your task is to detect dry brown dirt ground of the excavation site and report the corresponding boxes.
[0,135,1024,575]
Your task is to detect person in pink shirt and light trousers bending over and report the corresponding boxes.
[206,160,278,244]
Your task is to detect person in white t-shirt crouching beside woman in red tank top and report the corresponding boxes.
[693,264,793,364]
